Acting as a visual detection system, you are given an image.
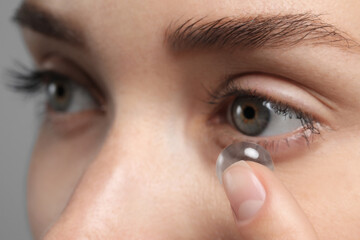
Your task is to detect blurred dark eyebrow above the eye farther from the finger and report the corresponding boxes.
[12,2,85,46]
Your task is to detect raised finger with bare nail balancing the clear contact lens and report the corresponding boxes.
[223,161,317,240]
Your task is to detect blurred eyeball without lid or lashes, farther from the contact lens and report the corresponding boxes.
[45,75,97,113]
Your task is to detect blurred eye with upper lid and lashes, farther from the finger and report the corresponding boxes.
[10,56,106,115]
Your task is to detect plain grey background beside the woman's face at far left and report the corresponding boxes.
[0,0,36,240]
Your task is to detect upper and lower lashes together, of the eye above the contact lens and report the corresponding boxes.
[207,81,320,145]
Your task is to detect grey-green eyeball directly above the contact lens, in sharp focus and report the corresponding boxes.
[228,96,308,136]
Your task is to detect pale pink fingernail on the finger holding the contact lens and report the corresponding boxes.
[223,161,266,223]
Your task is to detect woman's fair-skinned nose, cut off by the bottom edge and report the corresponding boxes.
[40,107,207,240]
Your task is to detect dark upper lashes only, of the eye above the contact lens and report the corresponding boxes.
[207,79,320,137]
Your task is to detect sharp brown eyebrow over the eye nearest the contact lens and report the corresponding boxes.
[164,13,359,52]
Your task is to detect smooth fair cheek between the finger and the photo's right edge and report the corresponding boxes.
[276,129,360,239]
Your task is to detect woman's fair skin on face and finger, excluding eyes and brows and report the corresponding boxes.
[17,0,360,240]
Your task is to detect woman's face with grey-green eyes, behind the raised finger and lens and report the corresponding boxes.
[18,0,360,239]
